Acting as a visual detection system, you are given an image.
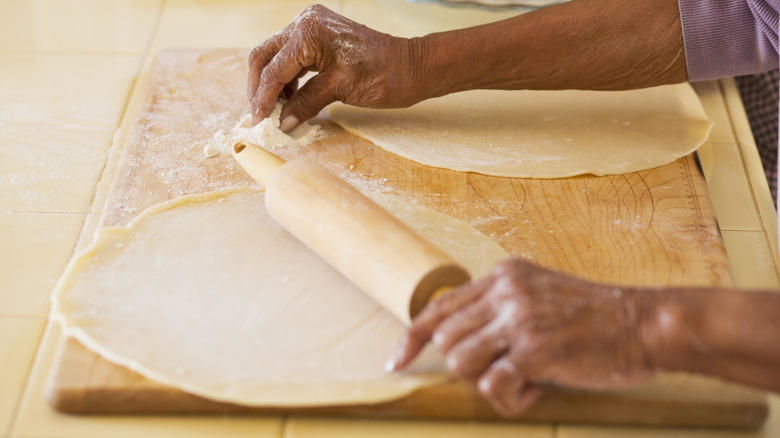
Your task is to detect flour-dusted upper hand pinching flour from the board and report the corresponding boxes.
[247,5,422,131]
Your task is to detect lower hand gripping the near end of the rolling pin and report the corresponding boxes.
[388,259,653,415]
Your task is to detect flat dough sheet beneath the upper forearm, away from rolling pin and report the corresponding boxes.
[329,83,712,178]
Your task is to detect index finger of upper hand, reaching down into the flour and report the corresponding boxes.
[252,36,314,123]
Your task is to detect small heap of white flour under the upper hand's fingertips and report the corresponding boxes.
[203,102,323,157]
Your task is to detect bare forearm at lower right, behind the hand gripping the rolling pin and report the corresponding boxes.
[641,289,780,391]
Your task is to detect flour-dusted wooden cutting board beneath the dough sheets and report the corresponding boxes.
[47,50,768,428]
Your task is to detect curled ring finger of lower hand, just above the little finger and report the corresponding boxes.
[446,330,509,381]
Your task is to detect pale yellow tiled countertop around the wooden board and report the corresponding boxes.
[0,0,780,438]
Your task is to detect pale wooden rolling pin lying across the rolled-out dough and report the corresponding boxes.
[232,141,469,324]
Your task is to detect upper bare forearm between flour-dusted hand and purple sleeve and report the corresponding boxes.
[413,0,687,98]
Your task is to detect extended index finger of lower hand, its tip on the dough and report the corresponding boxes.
[385,278,488,371]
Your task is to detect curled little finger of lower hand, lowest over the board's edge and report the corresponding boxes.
[477,356,541,416]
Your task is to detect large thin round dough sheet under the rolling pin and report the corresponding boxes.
[53,187,507,406]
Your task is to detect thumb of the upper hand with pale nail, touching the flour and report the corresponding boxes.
[280,73,336,132]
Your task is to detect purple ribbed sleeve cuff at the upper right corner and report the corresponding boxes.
[678,0,780,81]
